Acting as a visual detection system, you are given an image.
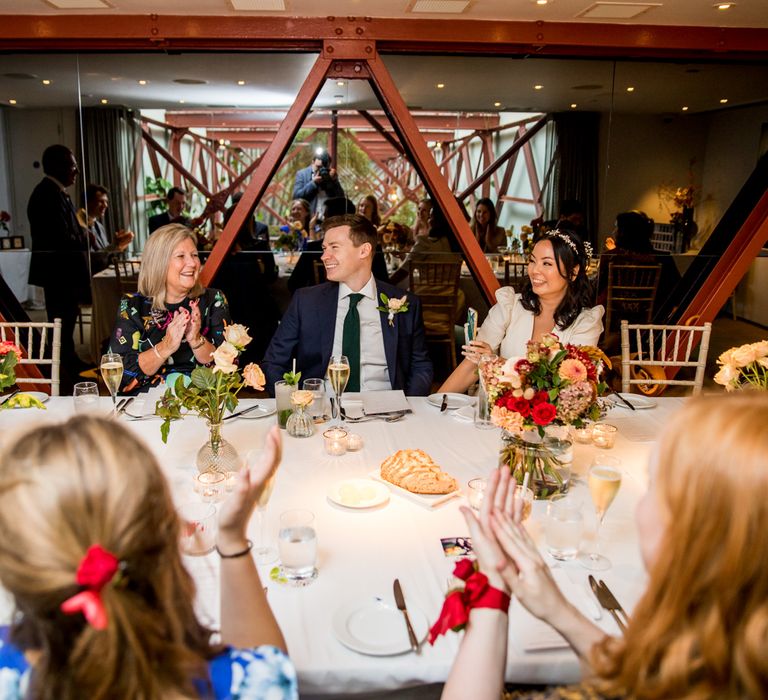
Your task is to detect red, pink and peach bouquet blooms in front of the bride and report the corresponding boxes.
[480,333,608,437]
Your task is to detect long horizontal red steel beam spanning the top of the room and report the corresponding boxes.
[0,13,768,59]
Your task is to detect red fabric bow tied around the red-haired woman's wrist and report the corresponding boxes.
[429,559,510,644]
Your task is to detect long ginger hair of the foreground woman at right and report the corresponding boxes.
[592,392,768,700]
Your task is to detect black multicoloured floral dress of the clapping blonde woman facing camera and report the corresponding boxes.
[109,289,231,394]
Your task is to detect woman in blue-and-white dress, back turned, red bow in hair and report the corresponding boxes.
[0,416,298,700]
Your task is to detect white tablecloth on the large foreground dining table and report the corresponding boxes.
[0,397,683,695]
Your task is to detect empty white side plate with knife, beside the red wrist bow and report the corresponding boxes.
[331,598,429,656]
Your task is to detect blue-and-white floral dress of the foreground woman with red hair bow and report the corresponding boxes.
[0,627,299,700]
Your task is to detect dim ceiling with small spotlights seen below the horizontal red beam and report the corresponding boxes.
[0,52,768,114]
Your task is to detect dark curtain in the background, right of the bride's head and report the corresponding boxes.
[552,112,600,245]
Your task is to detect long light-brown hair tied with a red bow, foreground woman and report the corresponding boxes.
[0,416,219,700]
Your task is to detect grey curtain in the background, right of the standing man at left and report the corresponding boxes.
[82,107,145,249]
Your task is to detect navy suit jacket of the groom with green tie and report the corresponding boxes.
[262,280,432,396]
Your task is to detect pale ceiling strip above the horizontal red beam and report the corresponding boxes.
[0,0,768,27]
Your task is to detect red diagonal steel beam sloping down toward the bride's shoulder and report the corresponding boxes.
[368,54,499,301]
